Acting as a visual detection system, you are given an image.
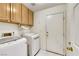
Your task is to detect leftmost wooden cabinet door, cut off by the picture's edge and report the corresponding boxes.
[0,3,10,22]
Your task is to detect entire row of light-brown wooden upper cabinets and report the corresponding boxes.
[0,3,33,25]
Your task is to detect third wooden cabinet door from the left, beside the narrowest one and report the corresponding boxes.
[22,5,29,24]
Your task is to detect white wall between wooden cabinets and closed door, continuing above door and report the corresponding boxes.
[32,5,65,50]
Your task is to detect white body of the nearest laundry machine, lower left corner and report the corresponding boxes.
[0,38,27,56]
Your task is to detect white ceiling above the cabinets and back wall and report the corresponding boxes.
[24,3,64,12]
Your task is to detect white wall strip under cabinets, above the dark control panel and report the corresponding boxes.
[0,22,19,38]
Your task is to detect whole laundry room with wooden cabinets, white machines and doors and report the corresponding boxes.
[0,3,79,56]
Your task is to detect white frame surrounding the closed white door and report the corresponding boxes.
[45,12,66,56]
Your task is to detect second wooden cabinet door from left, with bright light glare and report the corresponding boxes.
[11,3,21,23]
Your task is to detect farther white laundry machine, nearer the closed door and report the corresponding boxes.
[24,33,40,56]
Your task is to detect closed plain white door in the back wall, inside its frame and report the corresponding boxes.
[47,13,64,55]
